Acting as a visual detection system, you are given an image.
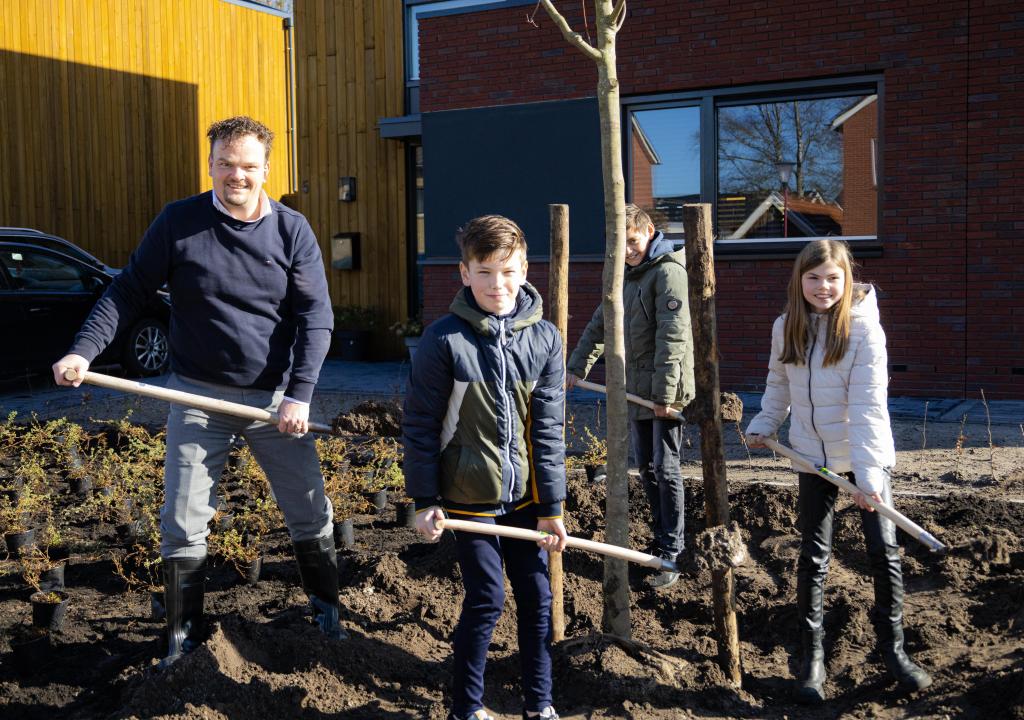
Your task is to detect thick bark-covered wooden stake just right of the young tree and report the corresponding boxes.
[683,205,741,687]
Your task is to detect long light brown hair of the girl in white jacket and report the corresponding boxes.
[779,240,853,368]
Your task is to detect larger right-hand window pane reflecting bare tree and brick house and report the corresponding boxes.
[717,95,878,240]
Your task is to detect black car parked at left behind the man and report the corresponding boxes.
[0,237,170,377]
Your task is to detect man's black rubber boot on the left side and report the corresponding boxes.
[160,557,206,669]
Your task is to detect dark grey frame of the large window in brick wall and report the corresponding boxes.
[622,75,885,258]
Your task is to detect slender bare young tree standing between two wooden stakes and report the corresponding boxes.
[541,0,631,638]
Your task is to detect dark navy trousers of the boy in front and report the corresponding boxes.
[452,508,552,718]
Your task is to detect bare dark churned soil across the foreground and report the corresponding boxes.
[0,405,1024,720]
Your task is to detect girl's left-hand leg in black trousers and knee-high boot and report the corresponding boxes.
[794,473,836,705]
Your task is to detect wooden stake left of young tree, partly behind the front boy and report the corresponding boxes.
[548,205,569,642]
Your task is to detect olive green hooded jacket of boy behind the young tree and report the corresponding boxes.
[566,232,694,420]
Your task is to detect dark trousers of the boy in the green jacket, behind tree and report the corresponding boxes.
[630,418,686,559]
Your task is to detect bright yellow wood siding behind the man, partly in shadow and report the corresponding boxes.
[0,0,289,265]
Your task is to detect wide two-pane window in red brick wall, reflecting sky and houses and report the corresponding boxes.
[628,80,882,244]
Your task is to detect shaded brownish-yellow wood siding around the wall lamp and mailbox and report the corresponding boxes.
[295,0,409,351]
